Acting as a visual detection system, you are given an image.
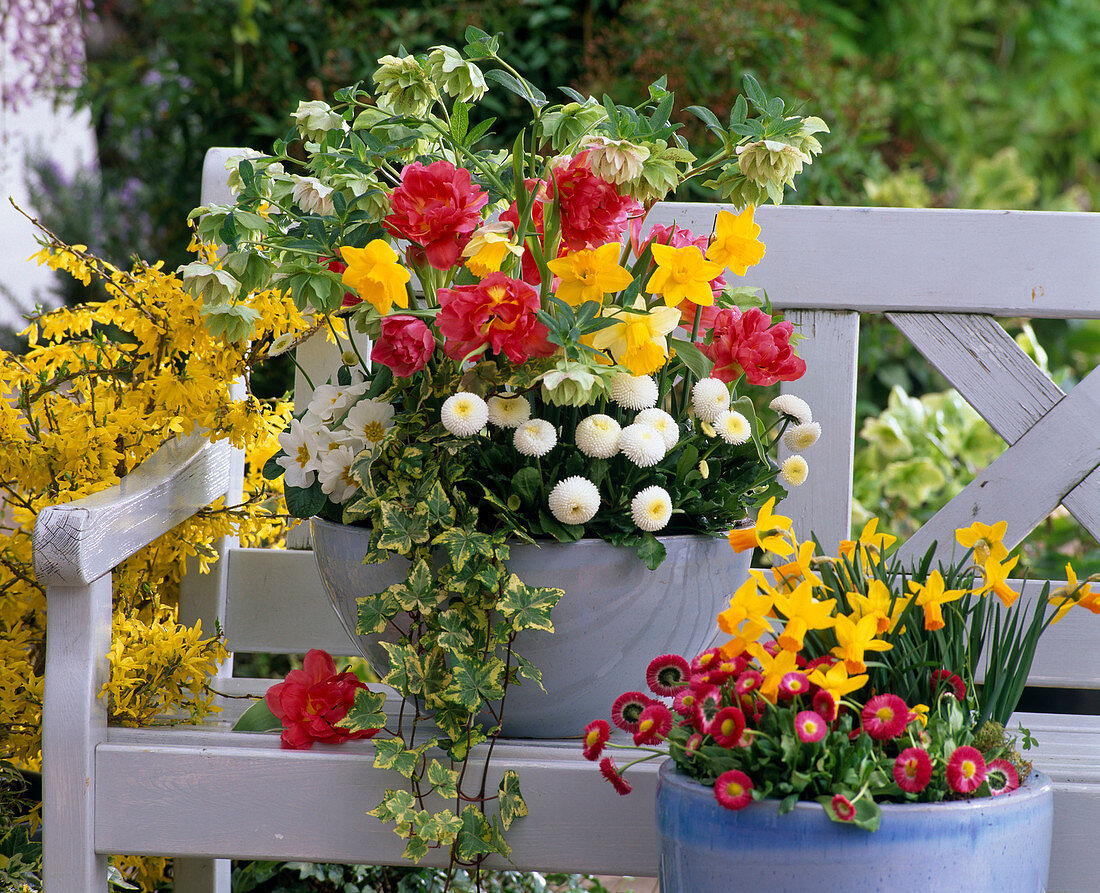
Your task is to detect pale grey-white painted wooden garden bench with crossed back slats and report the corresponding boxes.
[34,150,1100,893]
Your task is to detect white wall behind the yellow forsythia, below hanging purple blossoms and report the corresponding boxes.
[0,46,96,327]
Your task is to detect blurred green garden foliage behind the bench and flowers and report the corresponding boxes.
[0,0,1100,891]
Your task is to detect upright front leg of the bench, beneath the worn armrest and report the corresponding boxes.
[42,574,111,893]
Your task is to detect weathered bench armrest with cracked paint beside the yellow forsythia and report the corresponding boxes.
[34,434,233,586]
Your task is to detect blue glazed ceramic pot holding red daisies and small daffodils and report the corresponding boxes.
[657,760,1054,893]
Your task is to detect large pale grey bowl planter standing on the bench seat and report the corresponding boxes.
[311,518,751,738]
